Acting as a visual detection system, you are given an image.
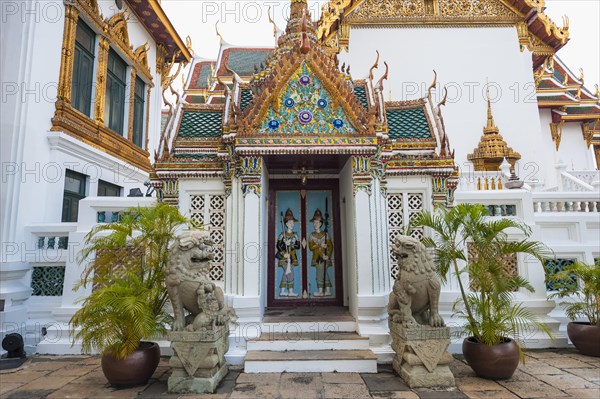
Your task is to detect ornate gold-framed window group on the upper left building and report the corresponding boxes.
[51,0,153,171]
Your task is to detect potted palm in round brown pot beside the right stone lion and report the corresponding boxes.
[412,204,550,379]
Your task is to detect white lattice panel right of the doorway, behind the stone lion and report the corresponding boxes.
[387,193,424,280]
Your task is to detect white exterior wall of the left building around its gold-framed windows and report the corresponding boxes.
[0,1,171,350]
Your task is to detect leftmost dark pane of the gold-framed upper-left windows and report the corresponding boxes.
[71,19,96,116]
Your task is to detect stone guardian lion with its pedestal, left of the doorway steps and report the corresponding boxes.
[166,230,235,393]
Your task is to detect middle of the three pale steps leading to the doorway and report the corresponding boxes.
[247,331,369,351]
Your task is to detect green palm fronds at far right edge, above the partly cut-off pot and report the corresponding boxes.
[548,260,600,327]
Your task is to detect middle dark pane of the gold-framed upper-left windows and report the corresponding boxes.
[104,49,127,136]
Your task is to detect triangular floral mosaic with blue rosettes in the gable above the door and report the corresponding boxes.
[259,63,356,134]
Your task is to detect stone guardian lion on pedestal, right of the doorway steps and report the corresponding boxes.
[388,236,455,388]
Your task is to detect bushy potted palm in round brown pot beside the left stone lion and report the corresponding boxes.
[70,203,187,386]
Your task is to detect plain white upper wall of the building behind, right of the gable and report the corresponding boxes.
[340,27,554,186]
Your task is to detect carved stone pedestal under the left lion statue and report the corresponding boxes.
[168,327,229,393]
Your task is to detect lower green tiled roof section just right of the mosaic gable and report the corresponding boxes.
[385,108,432,139]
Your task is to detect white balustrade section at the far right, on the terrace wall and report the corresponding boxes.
[532,192,600,213]
